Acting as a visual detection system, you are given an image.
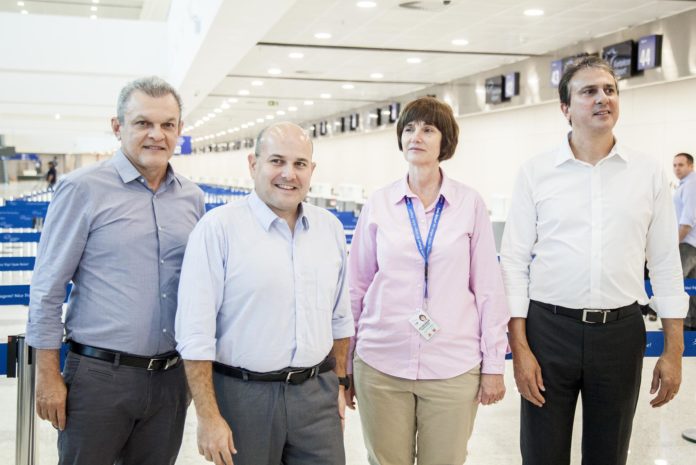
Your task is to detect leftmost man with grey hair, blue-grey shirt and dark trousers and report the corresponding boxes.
[27,77,205,465]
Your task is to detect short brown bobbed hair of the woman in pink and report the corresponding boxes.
[396,97,459,161]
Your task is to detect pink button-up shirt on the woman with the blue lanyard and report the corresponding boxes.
[348,174,510,379]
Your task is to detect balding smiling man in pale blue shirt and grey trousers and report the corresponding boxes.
[176,123,353,465]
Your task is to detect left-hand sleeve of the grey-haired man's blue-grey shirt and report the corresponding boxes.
[26,179,91,349]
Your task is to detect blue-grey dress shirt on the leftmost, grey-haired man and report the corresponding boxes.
[27,151,205,356]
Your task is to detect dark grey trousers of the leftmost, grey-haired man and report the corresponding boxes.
[58,352,189,465]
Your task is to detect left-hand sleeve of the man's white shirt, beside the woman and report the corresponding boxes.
[500,168,537,318]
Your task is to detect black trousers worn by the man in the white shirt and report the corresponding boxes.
[520,301,645,465]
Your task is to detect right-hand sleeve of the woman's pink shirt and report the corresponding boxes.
[469,193,510,374]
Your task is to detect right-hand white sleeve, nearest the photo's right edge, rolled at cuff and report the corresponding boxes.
[645,169,689,318]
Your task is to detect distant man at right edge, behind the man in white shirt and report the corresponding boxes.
[673,153,696,331]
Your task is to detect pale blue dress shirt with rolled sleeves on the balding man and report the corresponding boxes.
[176,192,354,372]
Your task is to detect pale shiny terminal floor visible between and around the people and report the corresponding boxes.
[0,306,696,465]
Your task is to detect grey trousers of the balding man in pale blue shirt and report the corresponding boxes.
[213,371,346,465]
